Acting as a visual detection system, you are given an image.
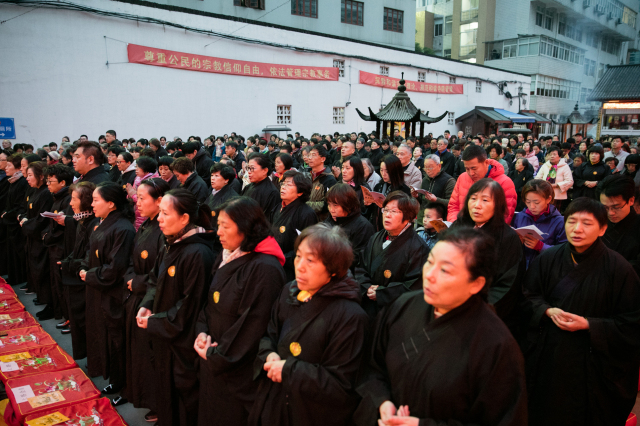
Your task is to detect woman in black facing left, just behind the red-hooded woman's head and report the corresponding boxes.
[242,153,280,223]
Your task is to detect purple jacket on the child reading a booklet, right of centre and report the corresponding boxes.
[511,204,567,268]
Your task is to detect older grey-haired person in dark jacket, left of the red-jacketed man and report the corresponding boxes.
[411,154,456,223]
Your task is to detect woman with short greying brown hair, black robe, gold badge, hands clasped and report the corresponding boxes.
[249,225,368,426]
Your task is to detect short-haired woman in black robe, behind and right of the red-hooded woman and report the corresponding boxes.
[271,170,318,281]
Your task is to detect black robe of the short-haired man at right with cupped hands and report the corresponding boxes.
[523,239,640,426]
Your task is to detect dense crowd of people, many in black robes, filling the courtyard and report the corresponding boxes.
[0,130,640,426]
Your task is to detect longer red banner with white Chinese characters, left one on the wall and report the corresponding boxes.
[127,44,338,81]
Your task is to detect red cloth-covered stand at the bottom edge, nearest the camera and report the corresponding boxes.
[25,398,127,426]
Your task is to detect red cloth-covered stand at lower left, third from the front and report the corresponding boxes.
[0,345,78,383]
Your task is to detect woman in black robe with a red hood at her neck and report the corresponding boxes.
[192,197,285,426]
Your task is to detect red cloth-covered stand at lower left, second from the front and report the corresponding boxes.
[5,368,100,425]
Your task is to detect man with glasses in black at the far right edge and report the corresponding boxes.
[600,175,640,274]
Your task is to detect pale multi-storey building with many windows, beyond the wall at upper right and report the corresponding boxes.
[416,0,640,134]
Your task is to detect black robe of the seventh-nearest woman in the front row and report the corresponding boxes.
[60,215,100,360]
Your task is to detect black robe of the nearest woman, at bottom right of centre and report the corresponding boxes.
[354,291,527,426]
